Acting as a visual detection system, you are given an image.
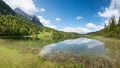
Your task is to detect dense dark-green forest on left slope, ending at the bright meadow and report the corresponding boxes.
[0,14,40,36]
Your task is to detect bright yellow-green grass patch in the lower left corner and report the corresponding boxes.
[0,46,36,68]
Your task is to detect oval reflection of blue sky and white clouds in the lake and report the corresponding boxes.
[40,38,106,57]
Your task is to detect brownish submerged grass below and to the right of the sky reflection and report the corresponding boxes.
[42,36,120,68]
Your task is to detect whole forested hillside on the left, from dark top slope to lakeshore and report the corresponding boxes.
[0,0,80,39]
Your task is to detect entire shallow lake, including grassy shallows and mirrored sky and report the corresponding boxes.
[0,36,120,68]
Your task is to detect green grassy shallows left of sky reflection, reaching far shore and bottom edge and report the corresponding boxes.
[0,39,83,68]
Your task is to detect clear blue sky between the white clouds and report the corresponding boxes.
[35,0,109,29]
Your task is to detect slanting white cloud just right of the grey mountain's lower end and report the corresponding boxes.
[38,16,56,29]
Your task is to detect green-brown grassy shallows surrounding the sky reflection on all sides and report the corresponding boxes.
[0,36,120,68]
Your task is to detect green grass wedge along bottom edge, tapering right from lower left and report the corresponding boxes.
[0,46,82,68]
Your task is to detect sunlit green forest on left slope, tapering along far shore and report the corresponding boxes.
[0,14,80,39]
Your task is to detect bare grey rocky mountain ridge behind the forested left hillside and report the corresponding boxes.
[14,8,43,27]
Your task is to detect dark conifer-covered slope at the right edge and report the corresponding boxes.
[93,17,120,39]
